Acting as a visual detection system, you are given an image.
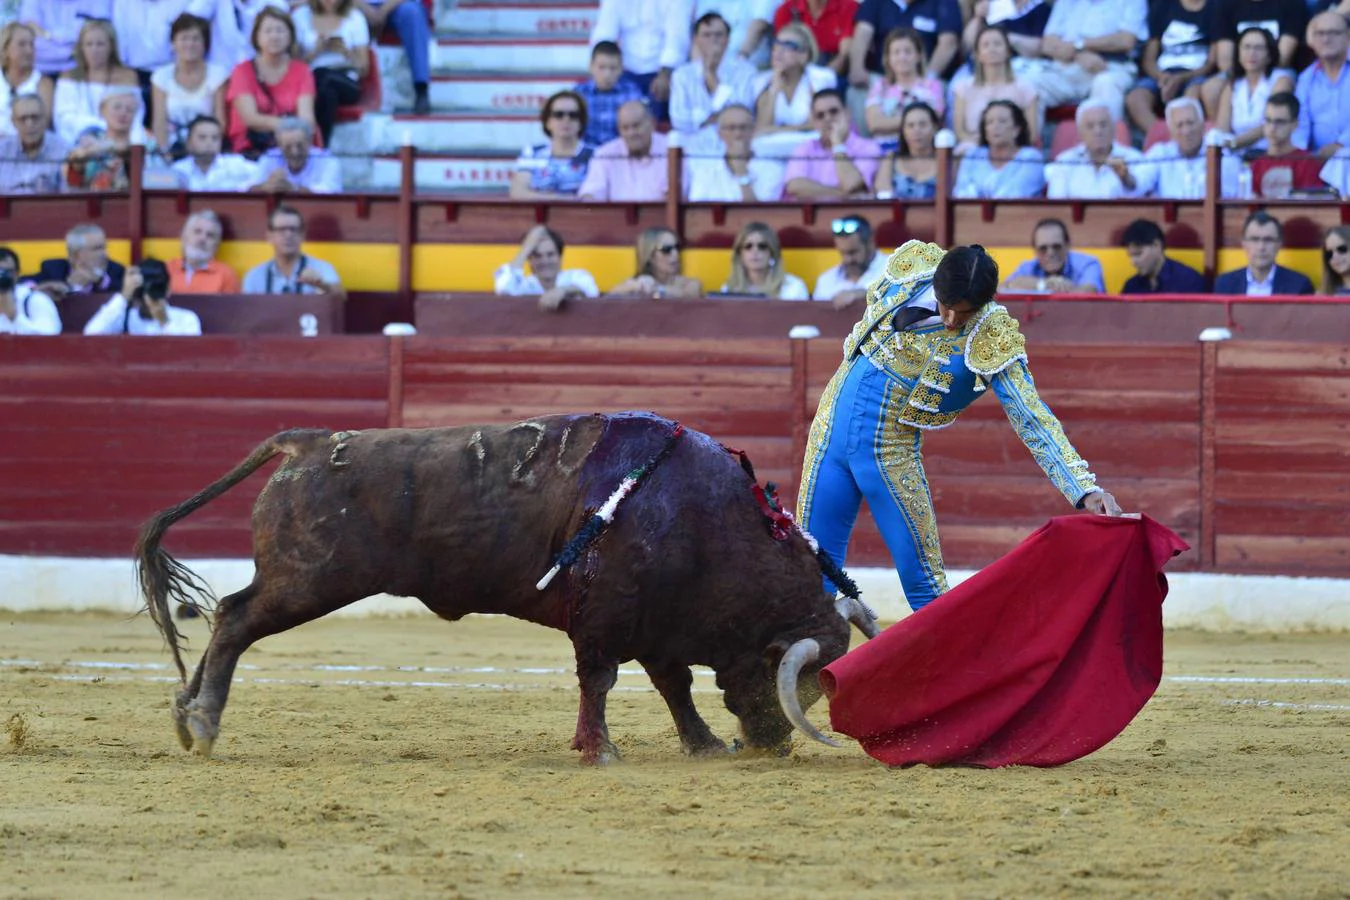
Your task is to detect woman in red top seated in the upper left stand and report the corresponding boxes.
[225,7,320,157]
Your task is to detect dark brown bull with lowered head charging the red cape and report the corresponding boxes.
[136,413,876,764]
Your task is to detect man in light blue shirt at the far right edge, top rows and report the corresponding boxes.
[1293,12,1350,159]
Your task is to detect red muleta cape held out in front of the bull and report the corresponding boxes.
[821,515,1189,768]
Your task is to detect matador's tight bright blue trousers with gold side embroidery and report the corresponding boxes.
[797,356,946,610]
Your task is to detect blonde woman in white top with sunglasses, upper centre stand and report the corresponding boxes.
[751,22,838,142]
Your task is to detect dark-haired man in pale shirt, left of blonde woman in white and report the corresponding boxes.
[671,12,759,147]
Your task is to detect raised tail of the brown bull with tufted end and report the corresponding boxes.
[135,429,328,683]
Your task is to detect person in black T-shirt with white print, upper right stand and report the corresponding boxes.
[1125,0,1220,134]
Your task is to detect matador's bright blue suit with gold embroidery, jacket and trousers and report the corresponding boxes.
[797,240,1098,610]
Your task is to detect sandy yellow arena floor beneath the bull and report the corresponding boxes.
[0,614,1350,900]
